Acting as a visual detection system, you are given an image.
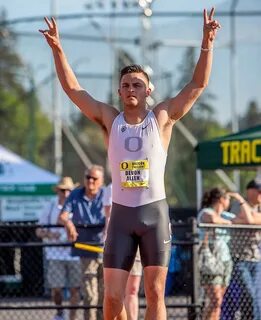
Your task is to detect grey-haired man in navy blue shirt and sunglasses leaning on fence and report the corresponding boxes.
[59,165,105,320]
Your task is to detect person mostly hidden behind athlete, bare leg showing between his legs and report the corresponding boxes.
[103,184,142,320]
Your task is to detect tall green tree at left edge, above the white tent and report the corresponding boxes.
[0,12,52,169]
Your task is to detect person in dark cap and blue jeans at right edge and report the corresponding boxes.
[222,180,261,320]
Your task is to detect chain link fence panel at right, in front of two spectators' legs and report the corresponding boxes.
[198,224,261,320]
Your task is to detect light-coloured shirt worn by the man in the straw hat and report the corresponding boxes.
[39,198,79,261]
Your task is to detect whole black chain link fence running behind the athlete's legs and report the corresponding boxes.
[0,219,261,320]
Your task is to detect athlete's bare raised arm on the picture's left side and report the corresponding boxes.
[39,17,118,131]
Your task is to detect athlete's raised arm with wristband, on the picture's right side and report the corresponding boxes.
[157,8,220,124]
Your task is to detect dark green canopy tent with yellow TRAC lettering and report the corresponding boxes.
[195,125,261,209]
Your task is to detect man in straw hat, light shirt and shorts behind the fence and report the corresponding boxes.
[36,177,81,320]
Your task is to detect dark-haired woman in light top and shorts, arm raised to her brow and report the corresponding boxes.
[198,188,246,320]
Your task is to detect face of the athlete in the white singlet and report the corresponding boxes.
[118,72,151,107]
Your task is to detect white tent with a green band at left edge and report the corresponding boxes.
[0,145,59,221]
